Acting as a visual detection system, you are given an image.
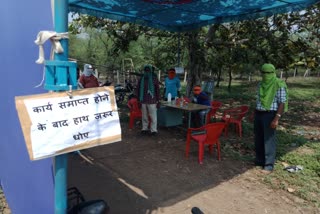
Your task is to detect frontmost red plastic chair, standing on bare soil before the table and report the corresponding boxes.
[185,122,226,164]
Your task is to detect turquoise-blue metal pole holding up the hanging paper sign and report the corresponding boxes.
[54,0,68,214]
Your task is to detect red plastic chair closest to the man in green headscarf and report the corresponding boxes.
[221,105,249,137]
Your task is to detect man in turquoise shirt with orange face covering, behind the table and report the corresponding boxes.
[164,68,181,100]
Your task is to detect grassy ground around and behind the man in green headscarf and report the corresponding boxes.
[214,78,320,207]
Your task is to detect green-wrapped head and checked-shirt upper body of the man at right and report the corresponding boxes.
[259,63,288,112]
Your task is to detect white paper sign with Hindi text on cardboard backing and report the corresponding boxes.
[16,87,121,160]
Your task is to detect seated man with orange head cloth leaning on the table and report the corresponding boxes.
[192,85,211,127]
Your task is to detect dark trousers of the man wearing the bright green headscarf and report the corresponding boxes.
[254,111,276,166]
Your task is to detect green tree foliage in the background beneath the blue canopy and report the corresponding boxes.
[69,4,320,90]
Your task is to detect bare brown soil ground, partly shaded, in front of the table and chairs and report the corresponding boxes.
[69,119,320,214]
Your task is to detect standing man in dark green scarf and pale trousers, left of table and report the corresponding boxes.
[137,65,160,135]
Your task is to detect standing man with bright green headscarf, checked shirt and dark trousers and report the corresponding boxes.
[254,64,288,173]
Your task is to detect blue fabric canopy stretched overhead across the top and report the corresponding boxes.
[69,0,319,32]
